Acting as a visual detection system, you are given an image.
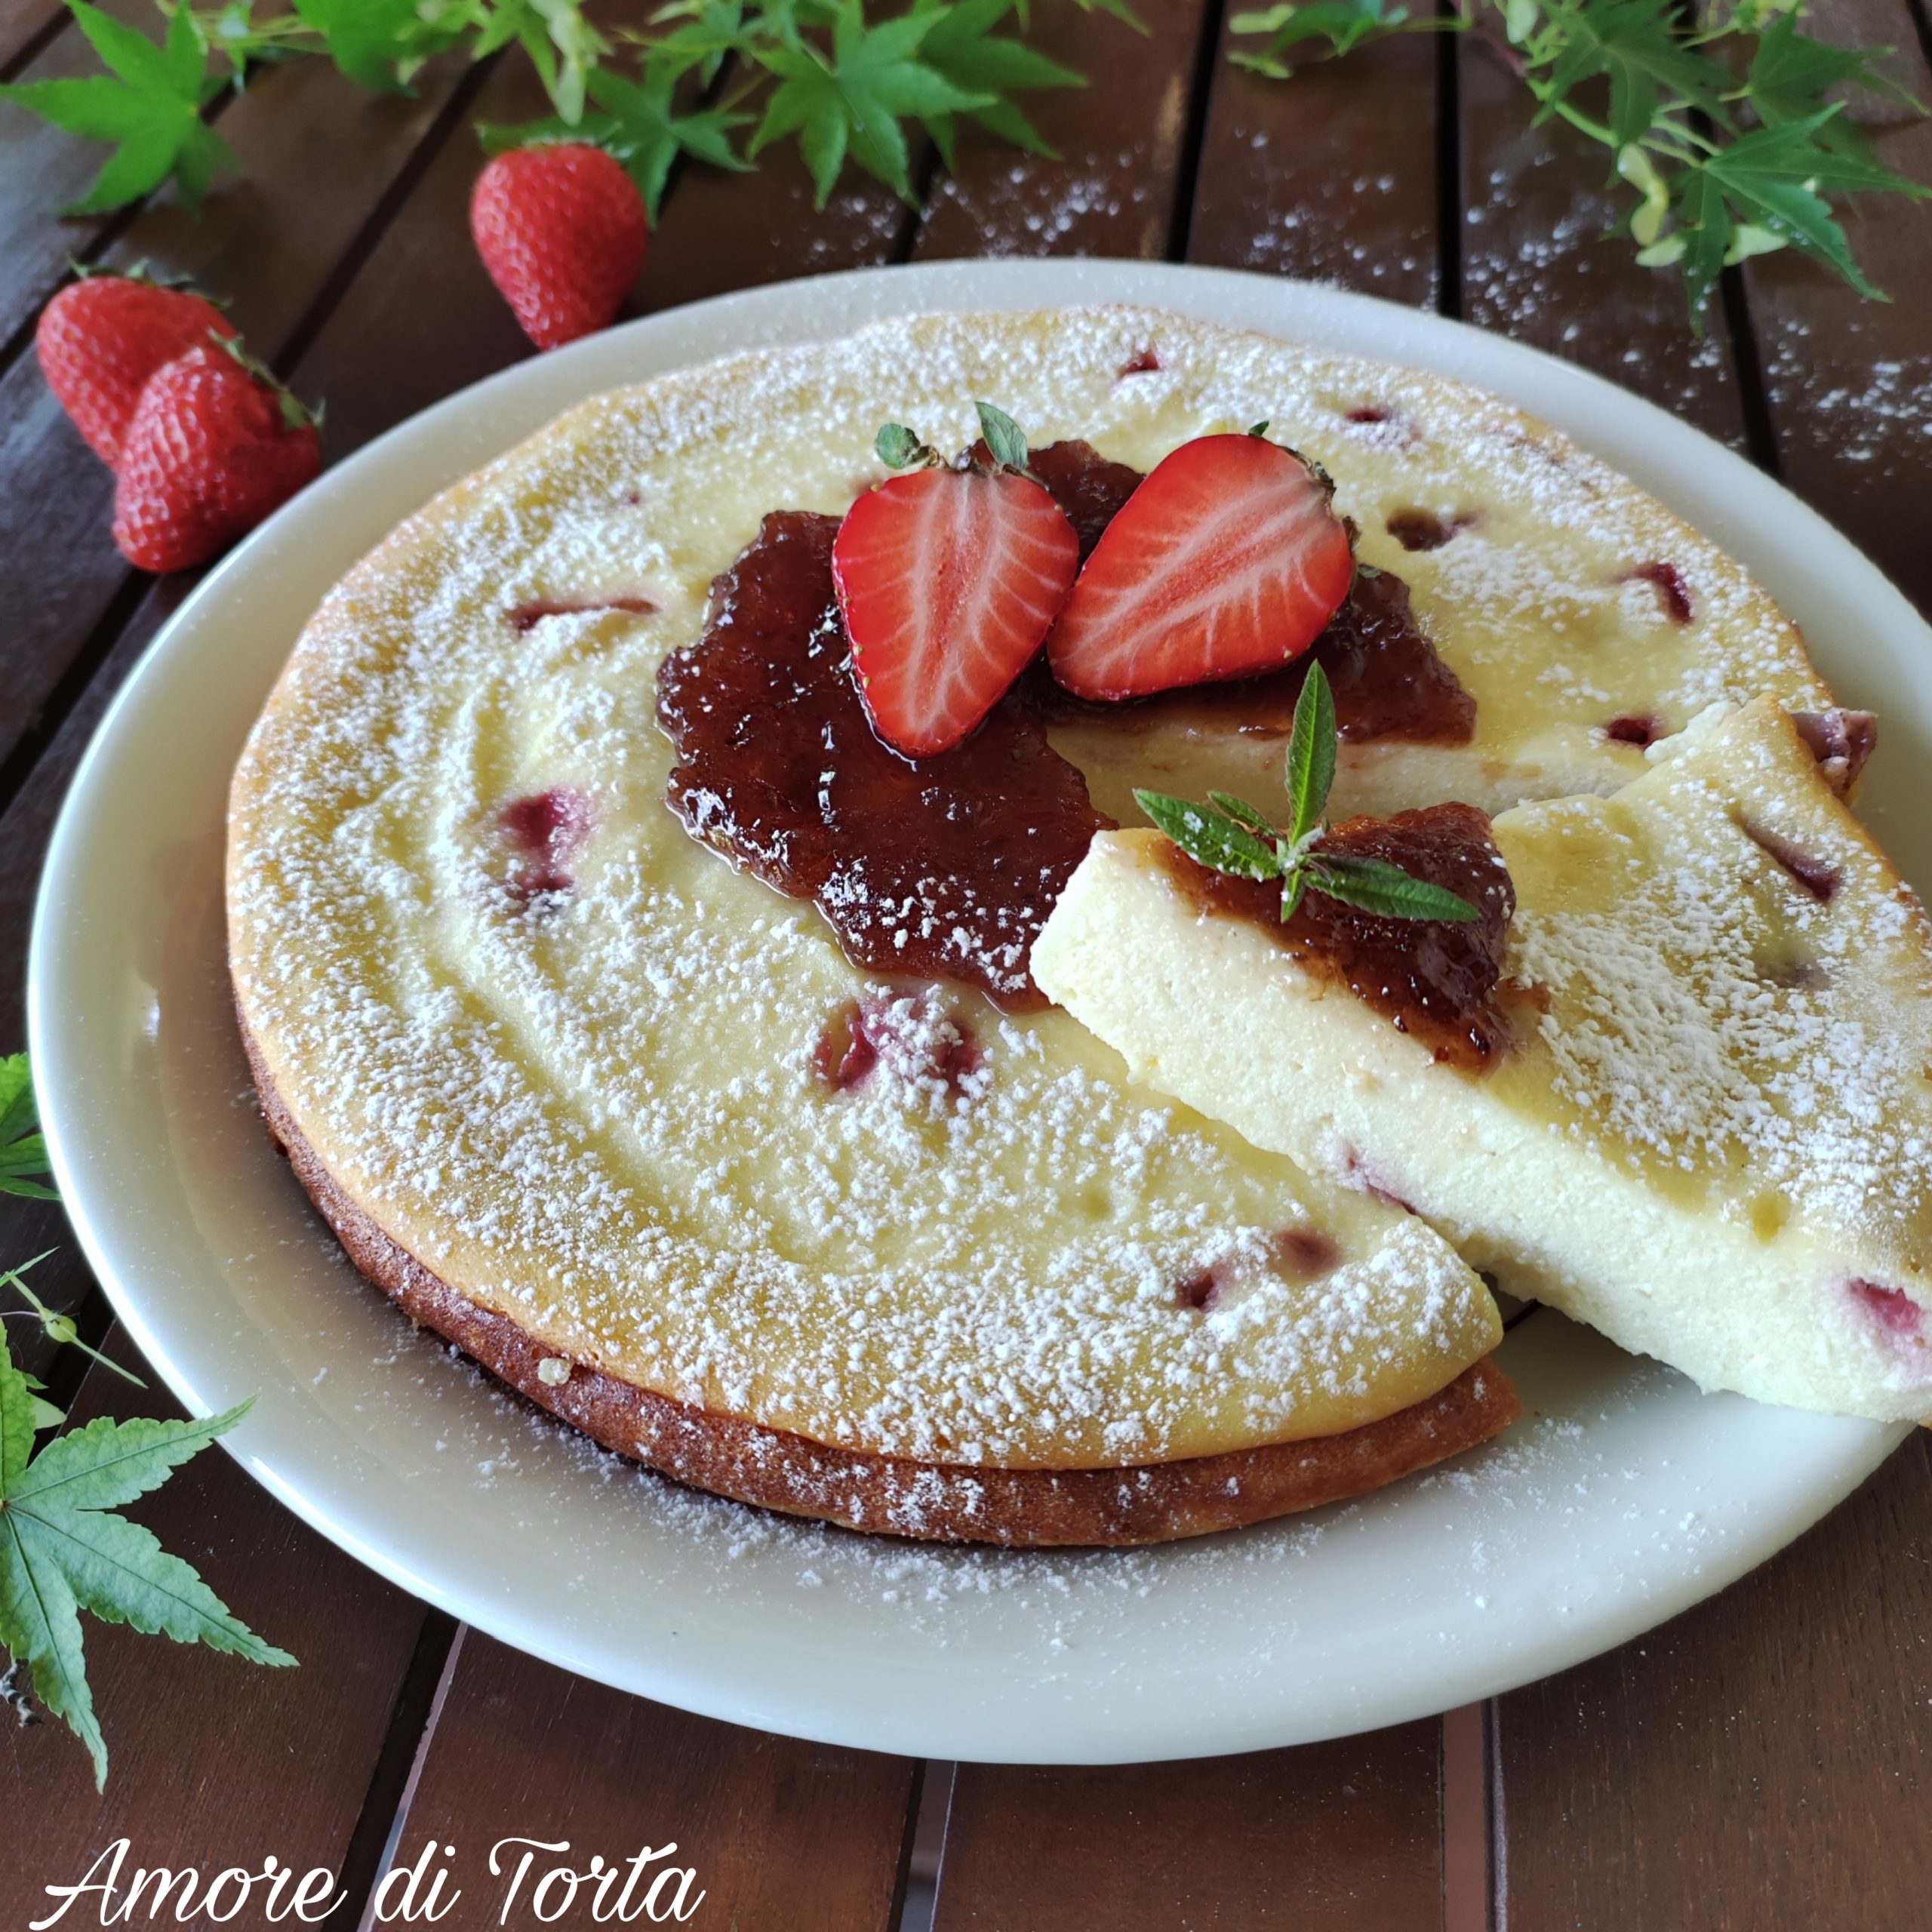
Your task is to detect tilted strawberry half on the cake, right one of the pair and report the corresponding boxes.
[1048,435,1355,700]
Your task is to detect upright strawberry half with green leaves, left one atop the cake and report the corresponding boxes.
[832,401,1080,758]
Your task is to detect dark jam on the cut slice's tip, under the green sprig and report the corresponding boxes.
[1163,806,1517,1072]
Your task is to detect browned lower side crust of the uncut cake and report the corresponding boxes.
[238,1014,1521,1548]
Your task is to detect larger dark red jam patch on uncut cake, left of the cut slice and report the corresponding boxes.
[657,510,1109,1011]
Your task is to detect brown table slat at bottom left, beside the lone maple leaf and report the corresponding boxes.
[0,1343,425,1926]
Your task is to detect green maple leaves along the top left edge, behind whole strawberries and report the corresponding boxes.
[0,0,1140,222]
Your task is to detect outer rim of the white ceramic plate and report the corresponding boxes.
[27,261,1932,1762]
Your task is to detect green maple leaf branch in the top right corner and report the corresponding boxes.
[1231,0,1932,332]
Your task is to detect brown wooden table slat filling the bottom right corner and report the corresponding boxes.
[1500,1434,1932,1932]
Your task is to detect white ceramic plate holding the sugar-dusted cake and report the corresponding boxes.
[31,263,1932,1762]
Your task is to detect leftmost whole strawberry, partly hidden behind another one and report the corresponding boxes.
[33,270,234,469]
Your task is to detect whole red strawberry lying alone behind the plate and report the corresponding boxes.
[469,141,648,349]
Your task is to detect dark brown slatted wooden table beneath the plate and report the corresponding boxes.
[0,0,1932,1932]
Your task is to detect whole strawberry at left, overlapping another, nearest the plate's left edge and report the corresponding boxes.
[114,344,323,570]
